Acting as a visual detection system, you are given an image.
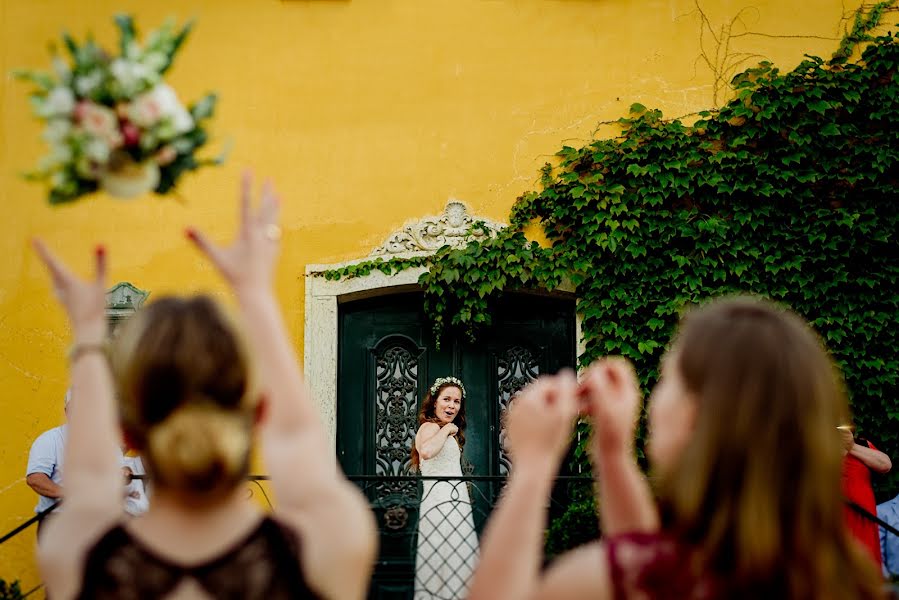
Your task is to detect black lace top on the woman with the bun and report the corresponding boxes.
[78,517,319,600]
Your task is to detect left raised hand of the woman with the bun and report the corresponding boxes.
[32,239,106,343]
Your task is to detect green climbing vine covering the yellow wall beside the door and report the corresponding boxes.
[323,0,899,548]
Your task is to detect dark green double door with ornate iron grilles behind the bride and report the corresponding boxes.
[337,294,575,599]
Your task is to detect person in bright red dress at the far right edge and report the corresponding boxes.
[840,427,893,569]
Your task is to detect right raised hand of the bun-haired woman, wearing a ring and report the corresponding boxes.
[187,172,281,293]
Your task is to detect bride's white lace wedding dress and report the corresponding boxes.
[415,436,478,600]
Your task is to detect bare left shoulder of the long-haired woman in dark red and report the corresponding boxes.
[531,541,612,600]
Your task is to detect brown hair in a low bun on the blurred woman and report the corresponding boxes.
[111,296,256,500]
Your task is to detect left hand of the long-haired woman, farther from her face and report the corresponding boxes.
[506,370,577,468]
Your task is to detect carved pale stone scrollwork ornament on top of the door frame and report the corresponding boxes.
[370,199,505,258]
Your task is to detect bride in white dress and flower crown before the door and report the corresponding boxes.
[412,377,478,600]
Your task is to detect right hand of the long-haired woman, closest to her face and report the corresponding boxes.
[579,358,641,452]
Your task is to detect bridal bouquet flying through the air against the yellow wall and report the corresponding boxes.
[14,15,222,204]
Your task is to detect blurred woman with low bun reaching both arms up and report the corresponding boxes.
[35,176,376,599]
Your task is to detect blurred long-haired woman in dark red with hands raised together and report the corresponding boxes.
[470,299,884,600]
